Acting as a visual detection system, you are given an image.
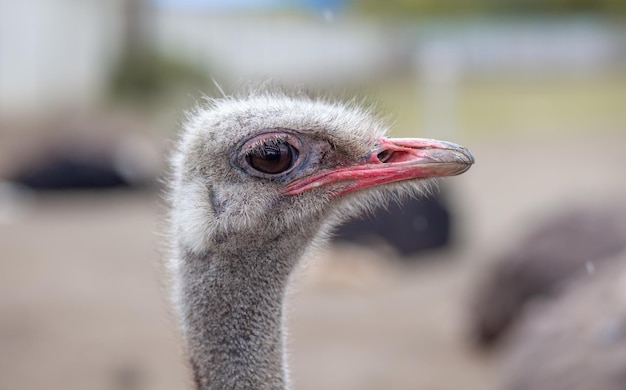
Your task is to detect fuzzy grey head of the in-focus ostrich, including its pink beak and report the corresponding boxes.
[172,94,474,256]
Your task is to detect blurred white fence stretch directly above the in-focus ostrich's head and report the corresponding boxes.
[151,10,398,85]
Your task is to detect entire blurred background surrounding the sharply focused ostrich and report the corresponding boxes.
[0,0,626,390]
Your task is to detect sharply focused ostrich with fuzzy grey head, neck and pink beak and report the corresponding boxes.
[169,92,474,390]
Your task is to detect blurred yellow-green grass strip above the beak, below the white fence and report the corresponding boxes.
[368,71,626,142]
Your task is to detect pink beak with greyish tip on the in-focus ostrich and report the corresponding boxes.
[283,138,474,196]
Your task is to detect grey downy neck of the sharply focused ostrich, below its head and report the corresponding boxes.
[180,230,305,390]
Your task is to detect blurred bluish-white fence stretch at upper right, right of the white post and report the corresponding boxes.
[413,18,626,76]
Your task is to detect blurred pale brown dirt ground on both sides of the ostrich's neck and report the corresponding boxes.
[0,134,626,390]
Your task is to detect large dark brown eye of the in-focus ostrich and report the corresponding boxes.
[246,139,298,175]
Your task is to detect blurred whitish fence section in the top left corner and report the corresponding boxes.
[0,0,123,117]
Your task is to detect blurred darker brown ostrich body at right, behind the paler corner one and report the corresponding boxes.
[471,205,626,348]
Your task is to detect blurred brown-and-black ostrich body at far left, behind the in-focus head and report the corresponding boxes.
[6,118,161,191]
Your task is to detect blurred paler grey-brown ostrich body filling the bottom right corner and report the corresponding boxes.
[499,251,626,390]
